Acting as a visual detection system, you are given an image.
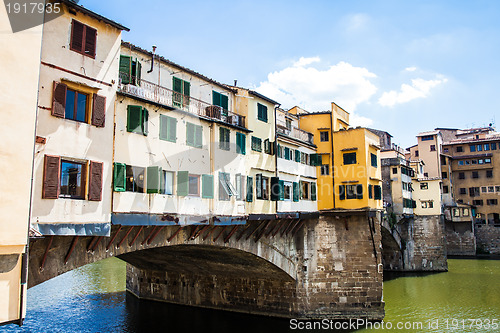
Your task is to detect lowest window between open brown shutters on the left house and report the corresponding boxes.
[59,160,85,199]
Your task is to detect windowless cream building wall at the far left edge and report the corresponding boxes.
[0,2,42,324]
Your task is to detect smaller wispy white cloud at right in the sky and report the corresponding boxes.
[378,78,448,106]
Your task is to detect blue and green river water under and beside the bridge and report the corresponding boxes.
[2,258,500,333]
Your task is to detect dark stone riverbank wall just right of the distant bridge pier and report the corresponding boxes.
[445,221,476,256]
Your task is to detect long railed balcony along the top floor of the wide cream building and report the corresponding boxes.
[118,75,245,127]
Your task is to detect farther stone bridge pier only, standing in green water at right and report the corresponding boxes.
[401,215,448,272]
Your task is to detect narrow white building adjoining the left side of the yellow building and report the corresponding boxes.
[276,108,318,213]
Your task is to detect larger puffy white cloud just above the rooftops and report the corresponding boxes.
[255,57,377,113]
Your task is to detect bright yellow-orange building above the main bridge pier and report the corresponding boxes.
[290,103,382,210]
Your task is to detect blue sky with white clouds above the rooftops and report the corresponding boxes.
[80,0,500,147]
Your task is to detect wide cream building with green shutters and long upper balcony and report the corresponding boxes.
[113,43,250,225]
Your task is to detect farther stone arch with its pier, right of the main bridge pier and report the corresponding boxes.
[381,215,448,272]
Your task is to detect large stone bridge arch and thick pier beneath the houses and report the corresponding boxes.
[28,210,384,320]
